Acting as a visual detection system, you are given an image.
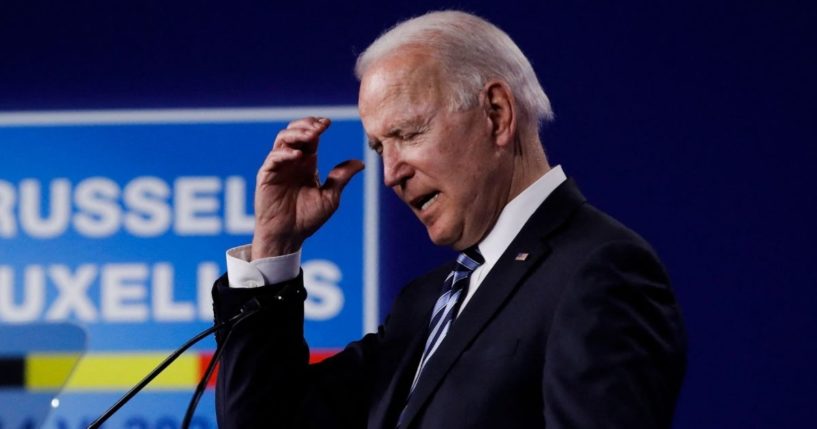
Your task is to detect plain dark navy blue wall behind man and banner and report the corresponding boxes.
[0,0,817,428]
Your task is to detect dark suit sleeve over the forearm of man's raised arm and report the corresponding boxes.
[213,275,309,428]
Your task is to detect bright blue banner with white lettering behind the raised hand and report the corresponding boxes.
[0,107,377,429]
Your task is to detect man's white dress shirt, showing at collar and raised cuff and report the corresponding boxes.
[227,165,567,311]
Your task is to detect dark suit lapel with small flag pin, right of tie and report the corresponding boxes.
[396,180,585,428]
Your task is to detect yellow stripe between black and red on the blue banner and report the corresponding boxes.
[27,353,199,391]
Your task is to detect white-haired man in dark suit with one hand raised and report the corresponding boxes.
[214,12,686,429]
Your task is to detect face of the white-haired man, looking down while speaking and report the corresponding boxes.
[359,48,512,250]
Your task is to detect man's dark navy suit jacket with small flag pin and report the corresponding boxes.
[214,181,686,429]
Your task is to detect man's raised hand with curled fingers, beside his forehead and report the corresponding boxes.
[252,117,363,259]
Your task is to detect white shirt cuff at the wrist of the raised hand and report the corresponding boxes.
[227,244,301,288]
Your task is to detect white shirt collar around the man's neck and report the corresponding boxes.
[479,165,567,266]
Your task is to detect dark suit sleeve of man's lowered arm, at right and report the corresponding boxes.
[542,242,686,429]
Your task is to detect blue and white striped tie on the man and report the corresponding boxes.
[397,246,485,428]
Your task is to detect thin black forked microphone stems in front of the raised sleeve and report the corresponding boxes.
[88,296,264,429]
